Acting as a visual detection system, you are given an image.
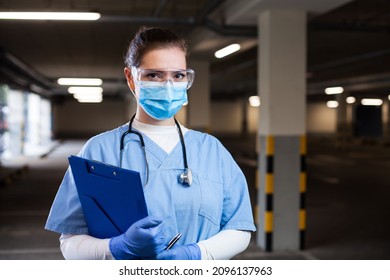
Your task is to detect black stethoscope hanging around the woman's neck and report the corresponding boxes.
[119,114,192,186]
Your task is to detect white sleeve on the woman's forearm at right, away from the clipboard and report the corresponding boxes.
[197,230,251,260]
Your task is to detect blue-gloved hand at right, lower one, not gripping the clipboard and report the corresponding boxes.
[156,243,201,260]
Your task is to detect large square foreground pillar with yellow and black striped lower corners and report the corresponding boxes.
[256,10,306,251]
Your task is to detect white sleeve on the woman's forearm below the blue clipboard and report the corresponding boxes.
[60,234,114,260]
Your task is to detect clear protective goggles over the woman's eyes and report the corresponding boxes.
[132,67,195,89]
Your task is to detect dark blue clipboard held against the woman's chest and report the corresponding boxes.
[68,156,148,238]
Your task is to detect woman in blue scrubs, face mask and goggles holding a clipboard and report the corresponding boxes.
[45,27,255,259]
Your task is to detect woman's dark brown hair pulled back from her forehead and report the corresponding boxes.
[124,26,187,67]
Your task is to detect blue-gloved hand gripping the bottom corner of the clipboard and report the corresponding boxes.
[109,216,165,260]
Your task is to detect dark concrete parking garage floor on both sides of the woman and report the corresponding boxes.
[0,137,390,260]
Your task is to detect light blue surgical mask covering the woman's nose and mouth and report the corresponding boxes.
[139,81,187,120]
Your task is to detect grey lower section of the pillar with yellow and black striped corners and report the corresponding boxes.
[256,135,307,252]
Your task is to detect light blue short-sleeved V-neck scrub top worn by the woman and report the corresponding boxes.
[45,124,256,244]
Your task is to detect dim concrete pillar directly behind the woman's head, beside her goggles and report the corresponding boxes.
[187,60,210,131]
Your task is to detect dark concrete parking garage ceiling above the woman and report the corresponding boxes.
[0,0,390,100]
